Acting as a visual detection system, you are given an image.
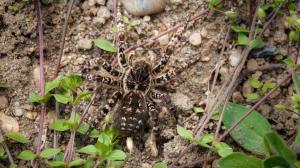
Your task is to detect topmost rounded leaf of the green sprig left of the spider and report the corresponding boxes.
[59,75,83,91]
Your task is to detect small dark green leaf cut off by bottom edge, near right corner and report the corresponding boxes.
[264,156,290,168]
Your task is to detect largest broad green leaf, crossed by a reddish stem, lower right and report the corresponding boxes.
[223,103,272,155]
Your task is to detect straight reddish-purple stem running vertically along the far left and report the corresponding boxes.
[34,0,46,154]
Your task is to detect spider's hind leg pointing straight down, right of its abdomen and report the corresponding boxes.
[147,98,158,157]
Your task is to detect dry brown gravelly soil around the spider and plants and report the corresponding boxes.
[0,0,299,168]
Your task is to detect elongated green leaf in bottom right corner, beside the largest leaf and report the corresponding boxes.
[264,132,297,167]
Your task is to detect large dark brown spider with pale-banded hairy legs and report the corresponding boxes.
[84,1,180,156]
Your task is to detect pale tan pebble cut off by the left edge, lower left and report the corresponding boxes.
[0,113,19,133]
